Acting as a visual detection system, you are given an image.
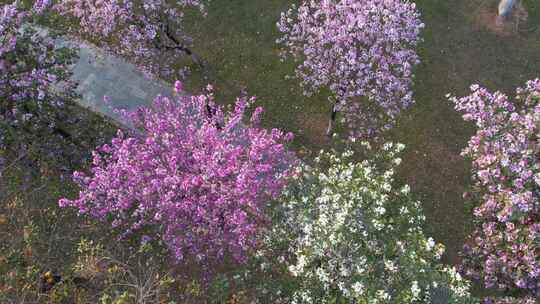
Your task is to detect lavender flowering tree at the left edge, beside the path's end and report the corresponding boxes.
[0,2,74,143]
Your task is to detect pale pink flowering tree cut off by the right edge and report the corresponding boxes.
[451,79,540,297]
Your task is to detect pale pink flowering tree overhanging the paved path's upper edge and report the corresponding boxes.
[56,0,204,77]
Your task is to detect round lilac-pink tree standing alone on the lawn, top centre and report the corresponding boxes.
[277,0,424,137]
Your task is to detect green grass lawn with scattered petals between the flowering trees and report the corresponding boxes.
[186,0,540,263]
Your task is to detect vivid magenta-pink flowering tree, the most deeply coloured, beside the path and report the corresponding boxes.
[60,82,294,266]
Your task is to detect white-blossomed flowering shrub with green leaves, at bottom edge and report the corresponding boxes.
[265,143,476,304]
